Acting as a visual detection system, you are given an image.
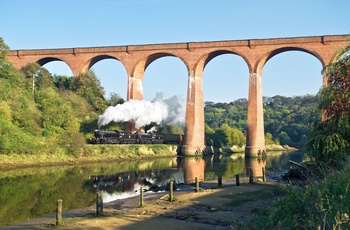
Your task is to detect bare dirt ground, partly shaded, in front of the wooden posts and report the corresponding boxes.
[6,178,279,230]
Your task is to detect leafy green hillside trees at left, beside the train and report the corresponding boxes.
[0,38,116,156]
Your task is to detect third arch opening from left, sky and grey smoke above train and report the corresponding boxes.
[143,55,188,134]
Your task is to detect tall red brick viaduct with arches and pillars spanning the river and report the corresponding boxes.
[7,35,349,156]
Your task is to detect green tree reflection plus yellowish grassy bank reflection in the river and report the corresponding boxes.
[0,157,176,226]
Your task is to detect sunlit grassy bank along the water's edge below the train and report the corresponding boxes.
[0,145,179,169]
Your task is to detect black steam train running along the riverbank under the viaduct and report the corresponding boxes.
[90,130,183,145]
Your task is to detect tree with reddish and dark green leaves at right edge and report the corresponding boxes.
[305,48,350,166]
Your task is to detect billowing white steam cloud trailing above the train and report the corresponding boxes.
[97,93,186,129]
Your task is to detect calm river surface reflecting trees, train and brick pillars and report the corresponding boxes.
[0,152,302,227]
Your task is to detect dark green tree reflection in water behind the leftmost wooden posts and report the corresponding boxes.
[0,167,95,226]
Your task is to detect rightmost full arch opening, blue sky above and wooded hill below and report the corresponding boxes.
[262,50,323,148]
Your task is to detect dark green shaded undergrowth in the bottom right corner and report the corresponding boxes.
[247,163,350,229]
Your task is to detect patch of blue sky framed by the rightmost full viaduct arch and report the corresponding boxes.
[262,50,323,97]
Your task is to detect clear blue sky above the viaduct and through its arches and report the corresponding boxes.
[0,0,350,102]
